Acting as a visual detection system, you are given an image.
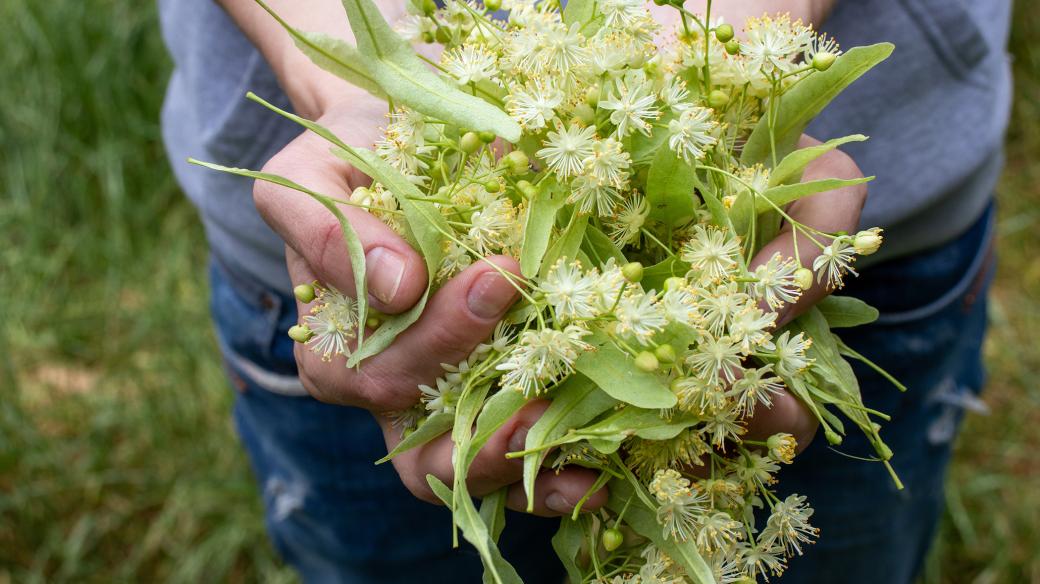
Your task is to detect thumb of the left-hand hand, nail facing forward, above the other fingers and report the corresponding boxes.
[253,126,426,314]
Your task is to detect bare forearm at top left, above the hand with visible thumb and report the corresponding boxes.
[217,0,405,118]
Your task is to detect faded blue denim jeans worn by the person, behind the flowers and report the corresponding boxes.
[211,204,993,584]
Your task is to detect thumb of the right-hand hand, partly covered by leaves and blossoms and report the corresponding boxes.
[749,136,866,327]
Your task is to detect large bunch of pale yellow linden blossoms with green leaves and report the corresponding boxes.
[195,0,899,584]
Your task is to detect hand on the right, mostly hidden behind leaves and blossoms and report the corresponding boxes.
[746,136,866,452]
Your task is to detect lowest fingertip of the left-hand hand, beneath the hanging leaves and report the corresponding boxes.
[505,467,608,517]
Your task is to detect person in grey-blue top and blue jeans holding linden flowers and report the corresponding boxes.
[159,0,1011,583]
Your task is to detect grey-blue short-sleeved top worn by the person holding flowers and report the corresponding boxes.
[159,0,1011,292]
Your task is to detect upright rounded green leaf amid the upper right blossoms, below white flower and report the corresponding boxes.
[646,148,697,225]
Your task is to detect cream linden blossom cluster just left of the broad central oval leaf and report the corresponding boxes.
[496,324,592,397]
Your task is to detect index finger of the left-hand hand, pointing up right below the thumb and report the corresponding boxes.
[360,256,520,407]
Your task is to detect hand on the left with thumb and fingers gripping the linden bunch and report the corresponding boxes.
[254,95,606,515]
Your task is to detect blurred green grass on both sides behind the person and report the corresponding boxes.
[0,0,1040,584]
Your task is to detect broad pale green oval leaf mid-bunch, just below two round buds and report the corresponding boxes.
[574,330,677,408]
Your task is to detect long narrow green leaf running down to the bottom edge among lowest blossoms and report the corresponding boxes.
[606,479,716,584]
